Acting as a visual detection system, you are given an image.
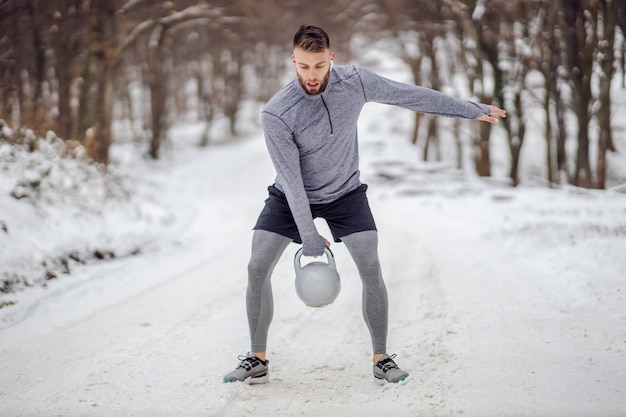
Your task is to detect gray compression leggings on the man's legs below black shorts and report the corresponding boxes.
[246,230,389,353]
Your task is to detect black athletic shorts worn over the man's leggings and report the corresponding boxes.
[254,184,376,243]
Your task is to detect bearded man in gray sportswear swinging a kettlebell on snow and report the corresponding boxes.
[224,26,506,383]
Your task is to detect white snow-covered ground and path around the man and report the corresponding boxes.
[0,96,626,417]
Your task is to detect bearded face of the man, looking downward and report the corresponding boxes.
[291,48,335,95]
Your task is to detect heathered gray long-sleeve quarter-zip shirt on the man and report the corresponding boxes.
[262,65,489,256]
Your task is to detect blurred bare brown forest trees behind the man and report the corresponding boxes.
[0,0,626,189]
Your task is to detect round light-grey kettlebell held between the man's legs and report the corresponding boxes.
[293,248,341,307]
